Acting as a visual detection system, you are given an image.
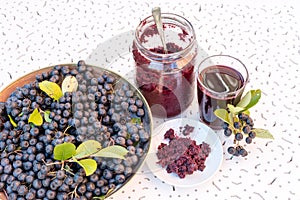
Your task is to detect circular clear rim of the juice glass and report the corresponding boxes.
[197,54,249,99]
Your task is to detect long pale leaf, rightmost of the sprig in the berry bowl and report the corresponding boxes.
[92,145,128,159]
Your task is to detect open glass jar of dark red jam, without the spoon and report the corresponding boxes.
[132,13,198,118]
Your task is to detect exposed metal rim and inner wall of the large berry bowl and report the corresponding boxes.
[0,64,153,200]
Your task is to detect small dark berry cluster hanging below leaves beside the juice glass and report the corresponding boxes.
[223,113,256,157]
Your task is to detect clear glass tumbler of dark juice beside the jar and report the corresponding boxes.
[197,55,249,130]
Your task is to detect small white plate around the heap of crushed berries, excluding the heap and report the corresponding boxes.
[146,118,223,187]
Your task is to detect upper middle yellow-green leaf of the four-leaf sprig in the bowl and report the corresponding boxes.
[75,140,101,159]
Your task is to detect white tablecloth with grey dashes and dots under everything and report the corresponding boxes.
[0,0,300,200]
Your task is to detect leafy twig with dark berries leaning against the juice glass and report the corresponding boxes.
[214,90,274,157]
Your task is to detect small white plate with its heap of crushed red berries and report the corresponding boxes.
[146,118,223,187]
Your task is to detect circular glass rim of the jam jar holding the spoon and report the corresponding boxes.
[135,13,196,59]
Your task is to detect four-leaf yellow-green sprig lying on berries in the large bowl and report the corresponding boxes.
[53,140,128,176]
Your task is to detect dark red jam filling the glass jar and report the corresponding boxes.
[133,45,195,117]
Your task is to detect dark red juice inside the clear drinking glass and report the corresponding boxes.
[197,65,245,129]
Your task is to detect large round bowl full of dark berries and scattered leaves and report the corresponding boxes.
[0,61,152,199]
